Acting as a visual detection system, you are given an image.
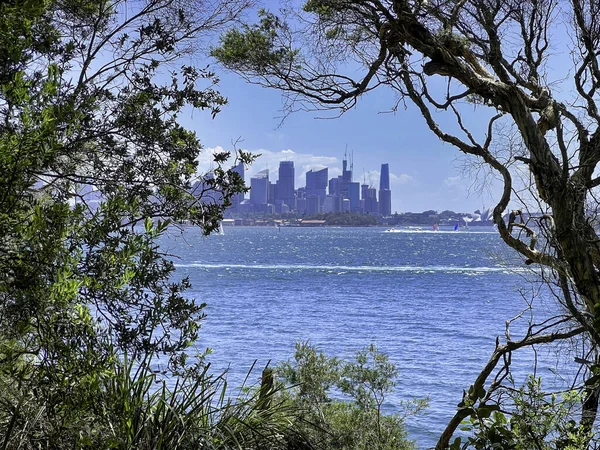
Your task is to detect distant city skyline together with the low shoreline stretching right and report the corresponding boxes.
[192,154,500,227]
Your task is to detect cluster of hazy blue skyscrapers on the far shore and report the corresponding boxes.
[216,155,392,217]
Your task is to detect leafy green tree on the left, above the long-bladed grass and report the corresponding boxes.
[0,0,247,363]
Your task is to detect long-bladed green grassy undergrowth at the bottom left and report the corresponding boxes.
[0,356,288,450]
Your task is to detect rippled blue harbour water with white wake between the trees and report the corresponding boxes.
[161,227,568,448]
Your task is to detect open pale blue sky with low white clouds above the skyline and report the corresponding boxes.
[188,69,506,212]
